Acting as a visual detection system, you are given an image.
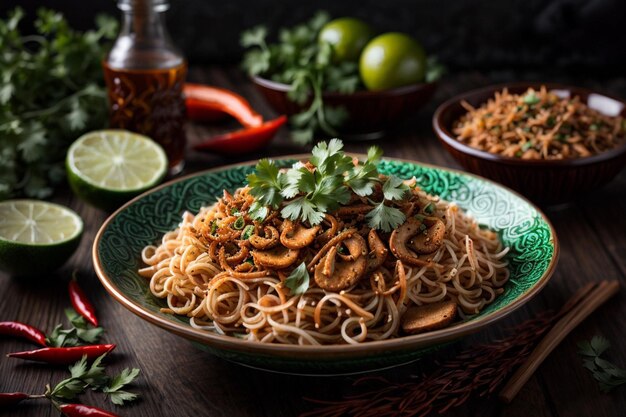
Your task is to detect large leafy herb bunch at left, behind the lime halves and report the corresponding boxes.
[0,8,117,200]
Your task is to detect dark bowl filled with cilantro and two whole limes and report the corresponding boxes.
[241,12,443,144]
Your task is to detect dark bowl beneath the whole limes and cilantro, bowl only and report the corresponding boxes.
[252,77,437,139]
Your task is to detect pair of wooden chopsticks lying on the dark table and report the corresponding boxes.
[499,280,619,403]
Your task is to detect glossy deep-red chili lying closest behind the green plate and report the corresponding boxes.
[193,116,287,155]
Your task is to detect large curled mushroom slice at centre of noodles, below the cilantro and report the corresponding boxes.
[315,233,367,291]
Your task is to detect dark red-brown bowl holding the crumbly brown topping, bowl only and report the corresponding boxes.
[433,83,626,204]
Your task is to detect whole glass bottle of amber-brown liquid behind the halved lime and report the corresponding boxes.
[103,0,187,175]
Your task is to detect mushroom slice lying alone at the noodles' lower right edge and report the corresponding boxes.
[402,301,457,334]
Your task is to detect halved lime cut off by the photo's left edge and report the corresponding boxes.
[0,200,83,275]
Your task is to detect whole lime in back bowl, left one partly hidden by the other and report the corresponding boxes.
[319,17,374,62]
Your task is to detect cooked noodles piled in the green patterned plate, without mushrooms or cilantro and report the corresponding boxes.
[139,182,509,345]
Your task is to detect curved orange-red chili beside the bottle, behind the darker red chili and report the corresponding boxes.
[183,83,263,127]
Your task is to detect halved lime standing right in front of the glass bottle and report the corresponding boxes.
[65,130,167,211]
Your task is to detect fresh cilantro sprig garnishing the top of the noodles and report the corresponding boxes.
[248,139,409,232]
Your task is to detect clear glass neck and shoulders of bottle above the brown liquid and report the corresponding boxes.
[107,0,184,69]
